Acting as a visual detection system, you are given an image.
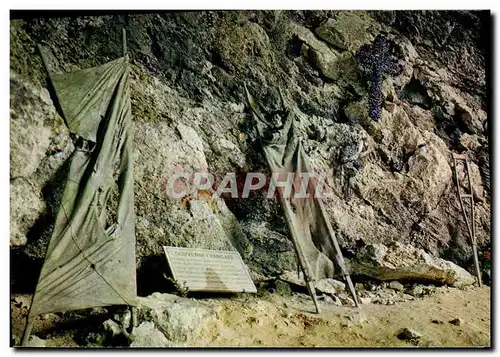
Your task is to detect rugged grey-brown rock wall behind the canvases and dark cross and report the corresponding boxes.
[10,11,490,295]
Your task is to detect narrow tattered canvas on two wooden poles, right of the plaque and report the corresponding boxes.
[245,85,358,312]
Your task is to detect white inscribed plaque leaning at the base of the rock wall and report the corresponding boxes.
[163,246,257,293]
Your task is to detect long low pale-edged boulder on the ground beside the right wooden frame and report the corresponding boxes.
[350,242,476,291]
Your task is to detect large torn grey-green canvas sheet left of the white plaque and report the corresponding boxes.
[23,38,137,344]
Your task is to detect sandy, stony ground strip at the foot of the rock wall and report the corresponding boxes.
[11,283,491,347]
